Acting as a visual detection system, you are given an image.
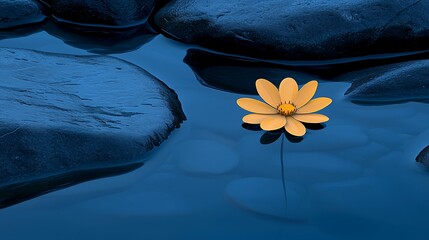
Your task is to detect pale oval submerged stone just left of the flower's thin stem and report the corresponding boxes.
[174,140,240,175]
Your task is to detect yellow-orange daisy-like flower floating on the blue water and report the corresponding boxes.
[237,78,332,136]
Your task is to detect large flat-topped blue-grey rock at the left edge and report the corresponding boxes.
[0,48,185,205]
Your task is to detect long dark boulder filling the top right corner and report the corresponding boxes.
[154,0,429,60]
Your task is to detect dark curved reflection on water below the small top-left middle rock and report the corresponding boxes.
[44,21,157,54]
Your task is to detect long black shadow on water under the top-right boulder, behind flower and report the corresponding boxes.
[183,48,429,94]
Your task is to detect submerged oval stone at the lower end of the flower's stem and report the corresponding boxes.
[225,177,305,221]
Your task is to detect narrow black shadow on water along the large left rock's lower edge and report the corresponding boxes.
[0,163,143,209]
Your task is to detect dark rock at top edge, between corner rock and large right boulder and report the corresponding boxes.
[40,0,156,28]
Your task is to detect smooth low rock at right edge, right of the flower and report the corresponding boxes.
[341,60,429,103]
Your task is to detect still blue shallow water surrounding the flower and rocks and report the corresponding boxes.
[0,32,429,239]
